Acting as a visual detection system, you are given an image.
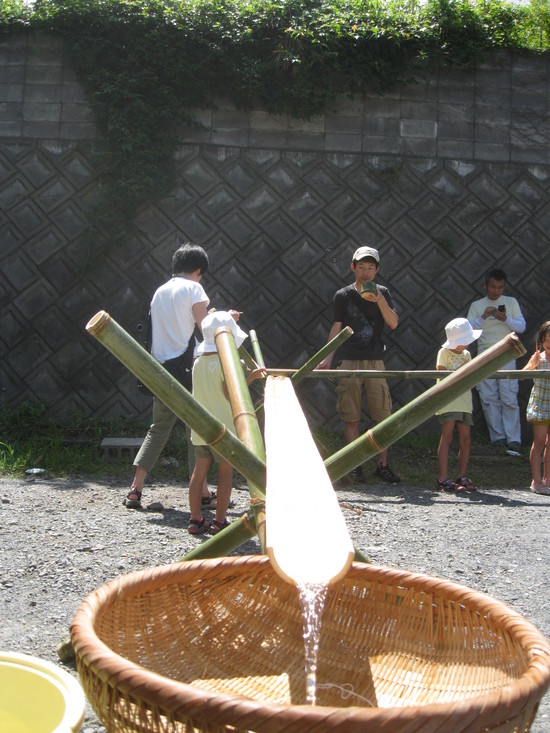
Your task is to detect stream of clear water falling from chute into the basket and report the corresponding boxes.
[298,583,328,705]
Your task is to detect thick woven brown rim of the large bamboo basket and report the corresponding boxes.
[70,555,550,733]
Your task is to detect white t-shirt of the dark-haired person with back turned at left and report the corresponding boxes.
[151,275,210,364]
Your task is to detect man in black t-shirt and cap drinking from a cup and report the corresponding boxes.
[317,246,401,484]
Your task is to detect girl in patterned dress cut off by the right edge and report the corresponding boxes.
[523,321,550,496]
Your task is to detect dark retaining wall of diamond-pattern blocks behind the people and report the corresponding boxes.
[0,141,550,428]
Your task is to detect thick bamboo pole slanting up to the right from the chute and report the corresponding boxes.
[325,333,525,481]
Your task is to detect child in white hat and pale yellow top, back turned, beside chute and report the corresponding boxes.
[188,311,266,535]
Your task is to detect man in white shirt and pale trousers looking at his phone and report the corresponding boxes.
[468,268,526,456]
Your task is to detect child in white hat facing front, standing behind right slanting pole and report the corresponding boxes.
[436,318,481,492]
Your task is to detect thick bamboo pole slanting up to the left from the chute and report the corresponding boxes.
[86,311,265,487]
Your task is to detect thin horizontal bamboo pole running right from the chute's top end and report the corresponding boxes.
[266,367,550,383]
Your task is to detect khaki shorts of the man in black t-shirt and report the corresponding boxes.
[336,359,392,423]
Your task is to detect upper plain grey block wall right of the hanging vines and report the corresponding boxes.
[184,53,550,164]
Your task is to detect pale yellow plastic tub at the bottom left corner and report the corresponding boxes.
[0,651,86,733]
